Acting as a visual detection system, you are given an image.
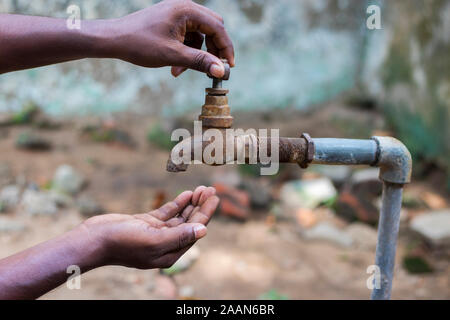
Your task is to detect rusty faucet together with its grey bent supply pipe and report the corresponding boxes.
[167,61,412,300]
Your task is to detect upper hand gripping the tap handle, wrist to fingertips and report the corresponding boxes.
[116,0,234,77]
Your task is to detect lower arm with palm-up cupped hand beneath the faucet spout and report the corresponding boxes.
[0,186,219,299]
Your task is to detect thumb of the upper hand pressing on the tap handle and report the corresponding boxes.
[178,44,225,78]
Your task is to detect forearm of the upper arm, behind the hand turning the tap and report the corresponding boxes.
[0,14,116,73]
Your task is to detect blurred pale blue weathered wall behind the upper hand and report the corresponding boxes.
[0,0,366,115]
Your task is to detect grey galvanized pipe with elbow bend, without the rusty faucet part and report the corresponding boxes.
[312,137,412,300]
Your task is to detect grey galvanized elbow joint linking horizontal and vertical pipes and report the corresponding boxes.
[372,137,412,184]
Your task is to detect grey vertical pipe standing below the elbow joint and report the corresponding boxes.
[371,182,403,300]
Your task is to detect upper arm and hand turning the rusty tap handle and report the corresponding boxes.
[0,0,234,77]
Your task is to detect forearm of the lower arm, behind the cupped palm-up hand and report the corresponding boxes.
[0,226,104,299]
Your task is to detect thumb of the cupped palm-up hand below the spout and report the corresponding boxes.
[158,223,206,253]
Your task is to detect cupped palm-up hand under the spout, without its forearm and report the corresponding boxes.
[82,186,219,269]
